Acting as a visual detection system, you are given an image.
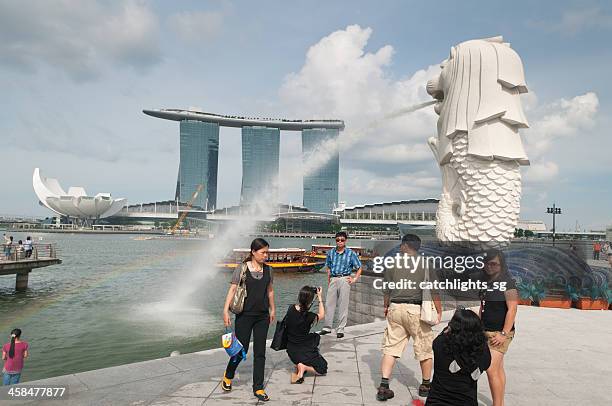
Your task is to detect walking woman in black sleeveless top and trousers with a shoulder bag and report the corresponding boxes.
[221,238,276,402]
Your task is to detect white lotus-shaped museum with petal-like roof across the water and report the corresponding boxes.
[32,168,127,219]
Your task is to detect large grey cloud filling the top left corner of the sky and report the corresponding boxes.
[0,0,161,81]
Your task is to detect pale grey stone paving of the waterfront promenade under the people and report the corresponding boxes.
[5,306,612,406]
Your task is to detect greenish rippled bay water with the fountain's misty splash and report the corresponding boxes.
[0,233,370,381]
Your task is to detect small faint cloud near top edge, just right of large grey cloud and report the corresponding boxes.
[168,11,223,42]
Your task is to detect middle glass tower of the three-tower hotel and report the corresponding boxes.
[240,127,280,204]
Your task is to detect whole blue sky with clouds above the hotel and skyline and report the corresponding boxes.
[0,0,612,229]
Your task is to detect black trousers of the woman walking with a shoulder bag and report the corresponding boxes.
[225,313,270,391]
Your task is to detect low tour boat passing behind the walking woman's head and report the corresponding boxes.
[218,248,325,272]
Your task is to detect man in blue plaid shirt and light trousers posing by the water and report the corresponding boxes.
[319,231,361,338]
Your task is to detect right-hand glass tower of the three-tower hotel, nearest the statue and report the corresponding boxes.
[302,128,340,214]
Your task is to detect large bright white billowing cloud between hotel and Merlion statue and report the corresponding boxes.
[279,25,439,203]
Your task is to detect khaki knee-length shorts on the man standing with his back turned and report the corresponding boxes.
[382,303,433,361]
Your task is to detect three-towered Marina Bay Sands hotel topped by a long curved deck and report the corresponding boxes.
[143,109,344,213]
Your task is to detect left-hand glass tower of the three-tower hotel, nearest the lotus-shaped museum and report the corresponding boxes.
[175,120,219,208]
